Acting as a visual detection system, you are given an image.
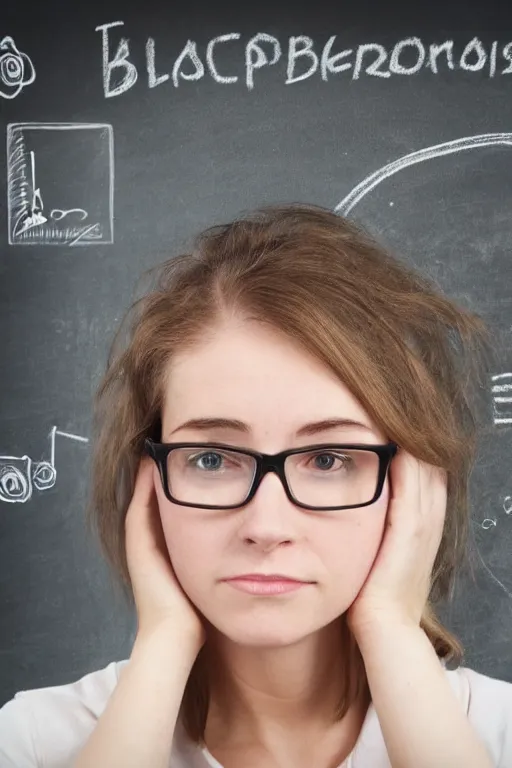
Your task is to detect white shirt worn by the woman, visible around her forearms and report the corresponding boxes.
[0,660,512,768]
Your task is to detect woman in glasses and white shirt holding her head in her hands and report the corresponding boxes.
[0,205,512,768]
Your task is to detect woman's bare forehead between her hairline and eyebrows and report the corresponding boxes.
[162,322,382,434]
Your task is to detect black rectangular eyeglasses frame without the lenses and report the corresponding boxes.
[144,437,398,512]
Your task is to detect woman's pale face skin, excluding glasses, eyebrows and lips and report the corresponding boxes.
[154,320,388,646]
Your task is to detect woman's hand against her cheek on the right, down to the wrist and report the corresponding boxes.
[347,450,447,639]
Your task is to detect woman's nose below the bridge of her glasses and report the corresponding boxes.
[238,472,300,551]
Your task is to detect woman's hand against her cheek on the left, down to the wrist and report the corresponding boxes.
[125,456,205,654]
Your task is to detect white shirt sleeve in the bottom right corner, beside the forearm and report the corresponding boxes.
[461,667,512,768]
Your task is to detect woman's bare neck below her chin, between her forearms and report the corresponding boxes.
[202,621,367,744]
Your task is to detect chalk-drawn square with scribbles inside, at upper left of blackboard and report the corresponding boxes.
[7,123,114,246]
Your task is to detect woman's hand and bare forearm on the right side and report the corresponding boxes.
[348,451,493,768]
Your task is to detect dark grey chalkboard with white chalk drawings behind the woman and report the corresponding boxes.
[0,0,512,702]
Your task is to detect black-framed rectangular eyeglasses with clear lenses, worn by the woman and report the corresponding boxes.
[144,438,398,511]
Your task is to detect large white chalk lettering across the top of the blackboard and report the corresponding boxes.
[96,21,512,98]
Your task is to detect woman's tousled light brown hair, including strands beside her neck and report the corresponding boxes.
[88,204,491,742]
